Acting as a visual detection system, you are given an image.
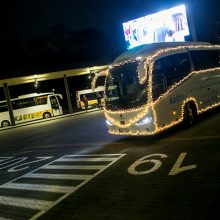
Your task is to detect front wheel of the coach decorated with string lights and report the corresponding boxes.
[183,102,197,127]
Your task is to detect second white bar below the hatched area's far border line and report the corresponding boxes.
[40,165,105,170]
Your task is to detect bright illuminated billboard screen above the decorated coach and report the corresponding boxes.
[123,5,189,49]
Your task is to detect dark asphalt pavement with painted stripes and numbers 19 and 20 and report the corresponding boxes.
[0,109,220,220]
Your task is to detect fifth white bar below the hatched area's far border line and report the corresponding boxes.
[0,196,53,210]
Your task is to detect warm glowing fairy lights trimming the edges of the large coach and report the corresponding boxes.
[92,45,220,135]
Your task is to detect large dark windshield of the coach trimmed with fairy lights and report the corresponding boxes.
[105,61,148,110]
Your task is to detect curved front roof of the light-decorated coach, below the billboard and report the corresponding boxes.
[113,42,210,65]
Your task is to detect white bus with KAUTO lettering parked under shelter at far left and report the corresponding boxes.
[0,93,63,127]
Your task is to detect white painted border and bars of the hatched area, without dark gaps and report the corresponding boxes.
[0,154,126,220]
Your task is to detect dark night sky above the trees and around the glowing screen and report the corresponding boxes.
[0,0,220,40]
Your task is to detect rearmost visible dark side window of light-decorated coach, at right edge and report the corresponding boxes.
[190,50,220,70]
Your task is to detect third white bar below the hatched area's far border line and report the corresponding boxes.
[23,173,93,180]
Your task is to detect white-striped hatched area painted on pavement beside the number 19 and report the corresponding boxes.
[0,154,125,220]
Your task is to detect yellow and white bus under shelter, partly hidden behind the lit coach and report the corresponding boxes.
[76,86,104,109]
